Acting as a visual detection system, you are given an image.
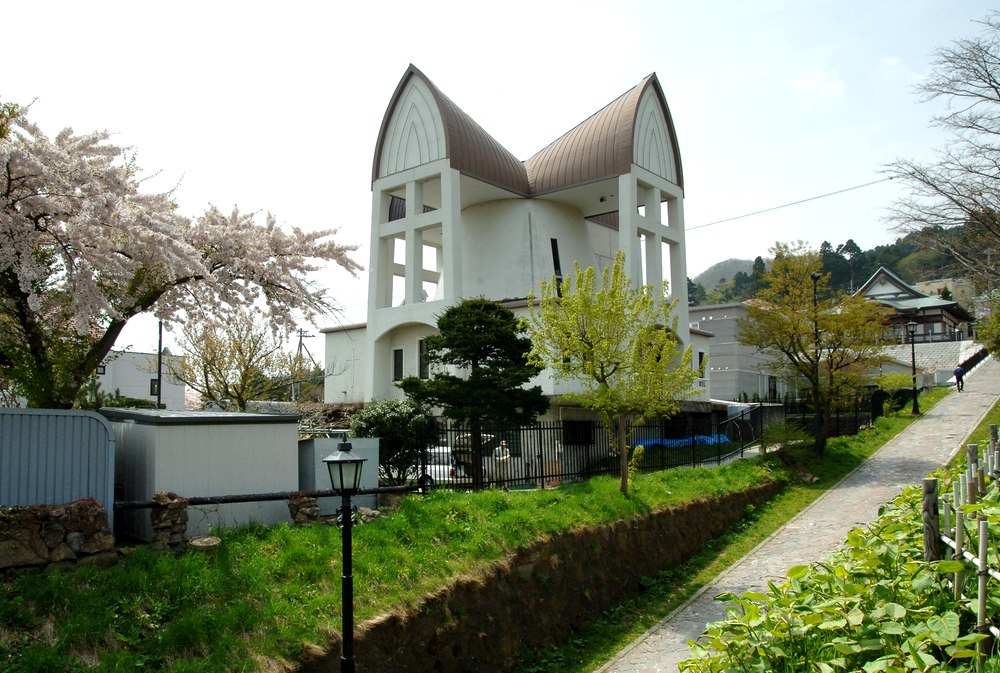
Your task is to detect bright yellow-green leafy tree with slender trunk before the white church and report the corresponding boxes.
[528,252,698,495]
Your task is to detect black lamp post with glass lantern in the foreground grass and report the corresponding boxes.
[323,440,366,673]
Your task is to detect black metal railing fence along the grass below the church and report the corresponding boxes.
[419,406,763,489]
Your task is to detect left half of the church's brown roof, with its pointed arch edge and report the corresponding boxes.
[372,64,530,196]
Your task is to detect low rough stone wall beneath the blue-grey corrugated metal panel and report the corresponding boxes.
[0,498,117,572]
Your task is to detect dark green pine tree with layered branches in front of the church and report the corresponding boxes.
[398,297,549,486]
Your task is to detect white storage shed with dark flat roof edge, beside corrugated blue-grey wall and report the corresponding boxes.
[101,408,299,541]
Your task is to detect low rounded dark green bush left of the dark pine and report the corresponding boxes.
[351,400,437,486]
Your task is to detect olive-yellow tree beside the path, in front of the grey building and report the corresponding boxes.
[738,242,888,453]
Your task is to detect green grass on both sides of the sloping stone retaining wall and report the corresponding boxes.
[0,391,944,673]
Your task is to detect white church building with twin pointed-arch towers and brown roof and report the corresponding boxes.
[322,65,710,417]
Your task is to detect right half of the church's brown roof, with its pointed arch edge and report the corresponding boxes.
[525,74,684,194]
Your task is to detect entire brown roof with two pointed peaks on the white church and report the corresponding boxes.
[372,64,684,196]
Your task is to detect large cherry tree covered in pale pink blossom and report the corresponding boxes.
[0,104,361,408]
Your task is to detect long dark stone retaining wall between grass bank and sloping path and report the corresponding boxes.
[298,483,784,673]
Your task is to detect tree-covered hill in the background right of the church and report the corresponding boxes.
[688,234,964,306]
